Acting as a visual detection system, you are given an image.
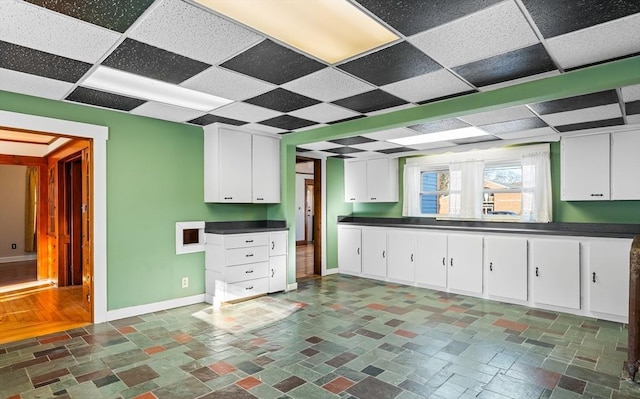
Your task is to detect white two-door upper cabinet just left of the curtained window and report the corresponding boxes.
[344,157,398,202]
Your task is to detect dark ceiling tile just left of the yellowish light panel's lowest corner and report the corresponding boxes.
[220,39,325,85]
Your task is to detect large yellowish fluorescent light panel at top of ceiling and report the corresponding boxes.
[196,0,398,64]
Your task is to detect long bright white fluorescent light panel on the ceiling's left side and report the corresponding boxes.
[82,66,233,112]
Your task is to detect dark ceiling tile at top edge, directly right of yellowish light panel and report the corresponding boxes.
[357,0,501,36]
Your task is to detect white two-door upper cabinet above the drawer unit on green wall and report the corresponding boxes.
[204,125,280,203]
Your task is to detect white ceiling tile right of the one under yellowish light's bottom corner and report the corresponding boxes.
[380,69,473,103]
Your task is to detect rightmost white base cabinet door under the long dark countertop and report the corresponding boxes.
[587,239,631,317]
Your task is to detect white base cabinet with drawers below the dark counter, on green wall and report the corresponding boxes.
[205,232,287,305]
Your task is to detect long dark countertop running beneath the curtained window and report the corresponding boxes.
[338,216,640,238]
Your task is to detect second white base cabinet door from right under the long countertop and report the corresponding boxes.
[531,239,580,309]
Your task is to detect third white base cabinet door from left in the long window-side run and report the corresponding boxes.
[387,231,416,283]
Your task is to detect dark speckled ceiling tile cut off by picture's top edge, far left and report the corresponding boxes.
[26,0,154,33]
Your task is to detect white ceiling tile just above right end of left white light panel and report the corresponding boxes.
[180,66,276,101]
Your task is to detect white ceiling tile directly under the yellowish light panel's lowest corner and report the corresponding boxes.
[282,68,374,102]
